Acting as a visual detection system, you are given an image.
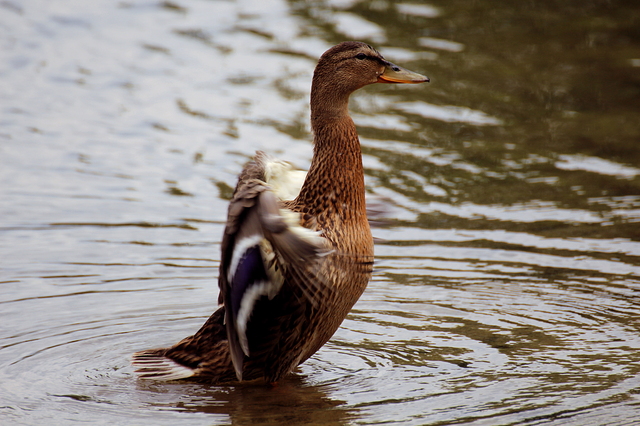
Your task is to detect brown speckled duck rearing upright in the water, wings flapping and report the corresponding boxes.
[132,41,429,384]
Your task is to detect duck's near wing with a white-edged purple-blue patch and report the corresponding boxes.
[219,171,326,380]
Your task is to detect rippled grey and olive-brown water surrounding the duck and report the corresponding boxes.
[0,0,640,425]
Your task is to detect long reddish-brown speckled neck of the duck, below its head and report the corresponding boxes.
[297,91,366,228]
